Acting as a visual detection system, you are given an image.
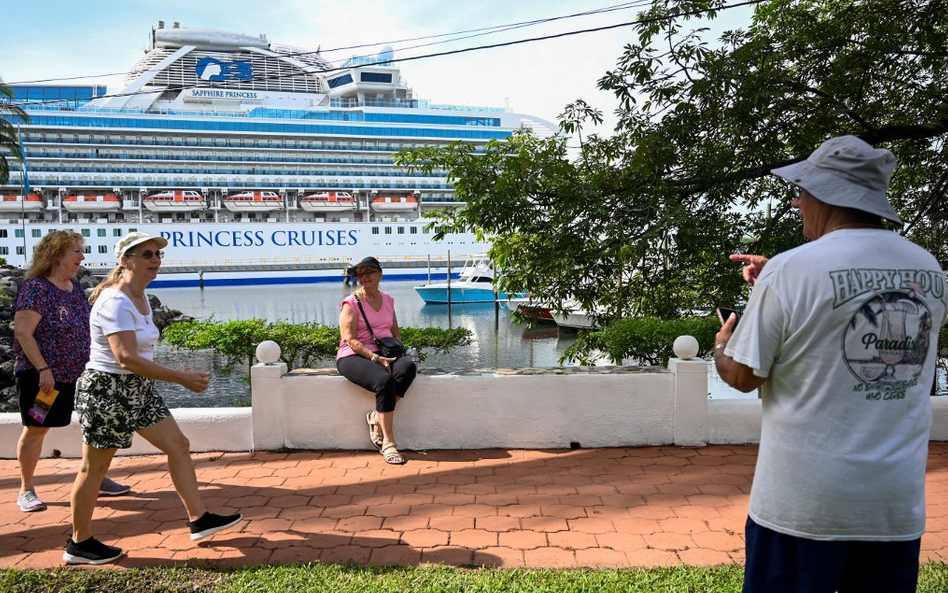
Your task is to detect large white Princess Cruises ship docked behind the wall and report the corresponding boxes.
[0,22,556,287]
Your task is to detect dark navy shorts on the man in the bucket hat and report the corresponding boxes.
[743,517,922,593]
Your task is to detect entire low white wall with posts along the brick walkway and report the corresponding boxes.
[0,359,948,459]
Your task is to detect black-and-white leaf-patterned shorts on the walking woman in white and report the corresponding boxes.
[76,369,171,449]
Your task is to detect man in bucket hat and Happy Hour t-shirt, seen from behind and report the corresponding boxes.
[714,136,946,593]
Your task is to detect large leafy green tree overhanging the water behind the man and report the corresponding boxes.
[399,0,948,340]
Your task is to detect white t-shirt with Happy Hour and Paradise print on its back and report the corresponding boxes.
[725,229,946,540]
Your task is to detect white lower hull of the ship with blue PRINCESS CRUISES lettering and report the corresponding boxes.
[0,220,487,288]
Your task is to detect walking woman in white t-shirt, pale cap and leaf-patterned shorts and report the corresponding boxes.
[63,233,242,564]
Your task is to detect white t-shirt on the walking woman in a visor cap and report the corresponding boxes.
[86,288,160,375]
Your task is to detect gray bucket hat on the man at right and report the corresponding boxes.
[771,136,902,224]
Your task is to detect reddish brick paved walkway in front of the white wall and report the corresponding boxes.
[0,443,948,568]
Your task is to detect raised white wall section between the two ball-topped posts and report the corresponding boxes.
[278,372,675,449]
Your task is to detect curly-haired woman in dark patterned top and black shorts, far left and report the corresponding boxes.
[13,231,130,513]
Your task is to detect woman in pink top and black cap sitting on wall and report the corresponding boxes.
[336,257,417,465]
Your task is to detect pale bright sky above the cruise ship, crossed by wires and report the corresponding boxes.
[0,0,750,133]
